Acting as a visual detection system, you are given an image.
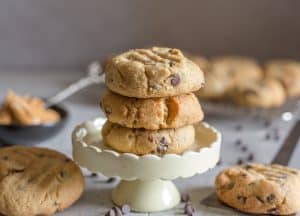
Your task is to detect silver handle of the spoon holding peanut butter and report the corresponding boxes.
[46,62,104,107]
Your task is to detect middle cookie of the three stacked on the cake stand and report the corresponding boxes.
[100,91,203,130]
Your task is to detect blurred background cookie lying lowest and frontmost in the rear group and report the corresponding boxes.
[232,79,286,108]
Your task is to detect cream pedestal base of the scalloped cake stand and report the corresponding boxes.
[112,179,180,212]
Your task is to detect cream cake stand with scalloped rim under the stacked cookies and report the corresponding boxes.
[72,118,221,212]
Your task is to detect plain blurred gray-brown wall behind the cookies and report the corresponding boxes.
[0,0,300,70]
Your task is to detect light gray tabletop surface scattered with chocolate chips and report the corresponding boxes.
[0,71,300,216]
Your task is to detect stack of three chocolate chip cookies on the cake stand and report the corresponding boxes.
[100,47,204,155]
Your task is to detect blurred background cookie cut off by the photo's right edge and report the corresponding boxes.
[265,60,300,97]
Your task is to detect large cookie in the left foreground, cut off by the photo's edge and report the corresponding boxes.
[0,146,84,216]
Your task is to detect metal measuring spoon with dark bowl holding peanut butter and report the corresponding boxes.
[0,62,104,146]
